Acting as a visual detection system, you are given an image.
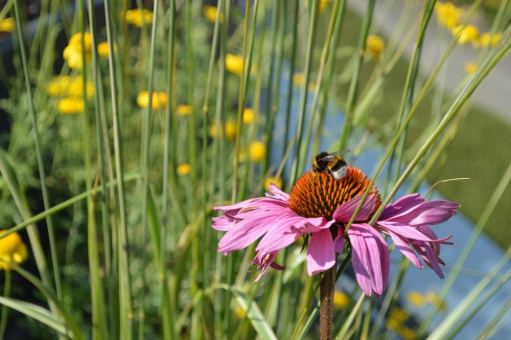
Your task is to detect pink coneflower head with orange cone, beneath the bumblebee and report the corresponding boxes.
[213,166,459,296]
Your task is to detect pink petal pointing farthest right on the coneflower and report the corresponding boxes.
[381,200,460,226]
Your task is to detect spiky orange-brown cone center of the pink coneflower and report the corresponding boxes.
[289,166,381,220]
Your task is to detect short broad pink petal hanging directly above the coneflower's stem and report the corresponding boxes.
[307,229,336,276]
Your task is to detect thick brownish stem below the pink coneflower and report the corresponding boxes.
[319,266,336,340]
